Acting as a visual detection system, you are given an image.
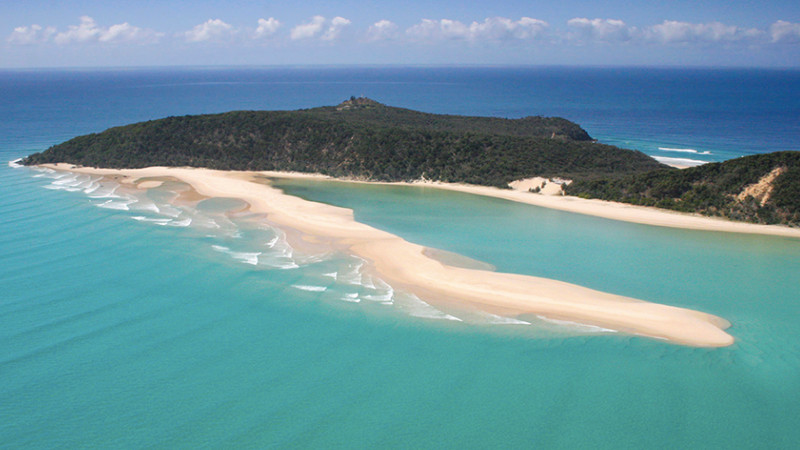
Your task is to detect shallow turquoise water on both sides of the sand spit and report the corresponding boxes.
[0,163,800,448]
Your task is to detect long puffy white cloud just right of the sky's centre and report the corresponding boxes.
[406,17,550,41]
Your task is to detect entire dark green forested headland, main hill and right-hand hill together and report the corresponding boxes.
[22,97,800,225]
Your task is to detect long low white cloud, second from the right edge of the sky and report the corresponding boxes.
[645,20,764,44]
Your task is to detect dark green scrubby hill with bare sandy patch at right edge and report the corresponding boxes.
[566,152,800,226]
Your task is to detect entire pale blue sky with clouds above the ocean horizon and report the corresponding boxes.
[0,0,800,68]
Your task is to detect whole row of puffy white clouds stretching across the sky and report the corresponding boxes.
[6,15,800,47]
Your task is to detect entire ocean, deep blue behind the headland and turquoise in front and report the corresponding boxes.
[0,67,800,448]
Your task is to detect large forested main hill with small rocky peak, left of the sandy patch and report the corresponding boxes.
[23,98,663,187]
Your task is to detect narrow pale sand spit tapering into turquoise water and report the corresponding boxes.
[40,165,734,347]
